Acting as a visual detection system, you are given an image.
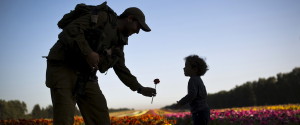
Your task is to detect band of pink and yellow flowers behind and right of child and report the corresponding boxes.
[165,105,300,125]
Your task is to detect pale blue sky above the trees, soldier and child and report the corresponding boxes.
[0,0,300,112]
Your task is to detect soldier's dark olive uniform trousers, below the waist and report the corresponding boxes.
[50,82,110,125]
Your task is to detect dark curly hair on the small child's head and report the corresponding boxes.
[184,55,208,76]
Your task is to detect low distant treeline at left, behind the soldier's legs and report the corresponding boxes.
[0,99,134,120]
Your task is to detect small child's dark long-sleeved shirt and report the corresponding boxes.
[178,76,209,113]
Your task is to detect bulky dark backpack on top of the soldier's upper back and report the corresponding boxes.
[57,2,117,29]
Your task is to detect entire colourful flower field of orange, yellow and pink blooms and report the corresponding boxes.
[0,105,300,125]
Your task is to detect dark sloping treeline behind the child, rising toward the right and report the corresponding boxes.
[163,67,300,109]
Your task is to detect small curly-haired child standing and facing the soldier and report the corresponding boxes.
[177,55,210,125]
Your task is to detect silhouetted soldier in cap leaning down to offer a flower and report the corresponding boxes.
[46,2,156,125]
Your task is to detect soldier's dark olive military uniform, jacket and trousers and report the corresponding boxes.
[46,2,142,125]
